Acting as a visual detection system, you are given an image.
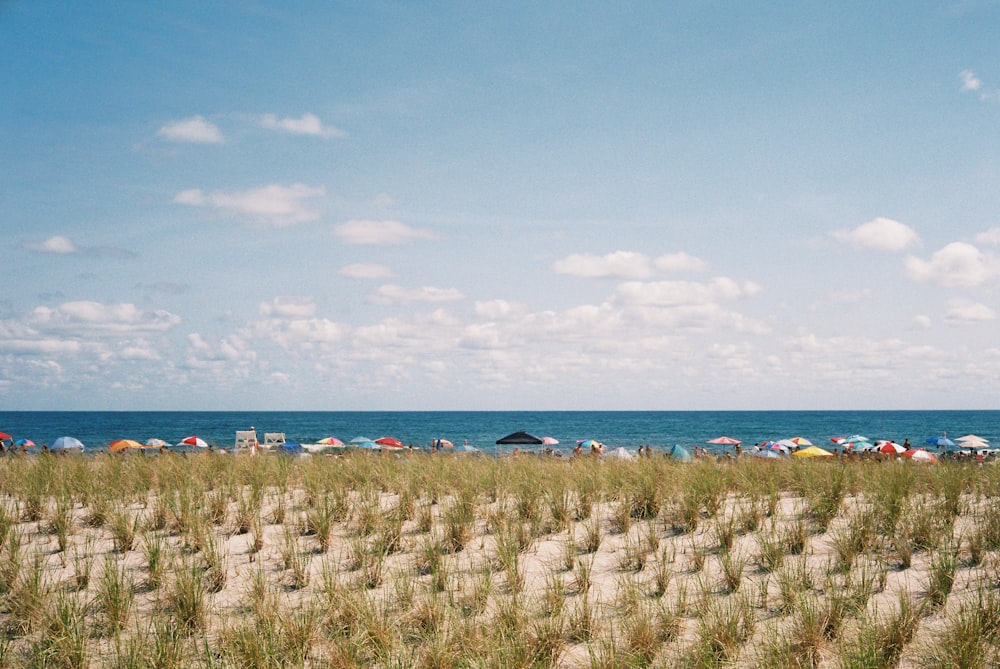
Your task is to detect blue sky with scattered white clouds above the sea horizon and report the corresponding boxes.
[0,0,1000,410]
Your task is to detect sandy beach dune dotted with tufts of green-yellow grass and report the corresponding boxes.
[0,453,1000,667]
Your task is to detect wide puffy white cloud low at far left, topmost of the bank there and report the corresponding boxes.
[27,301,181,337]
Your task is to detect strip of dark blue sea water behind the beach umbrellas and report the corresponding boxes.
[0,411,1000,453]
